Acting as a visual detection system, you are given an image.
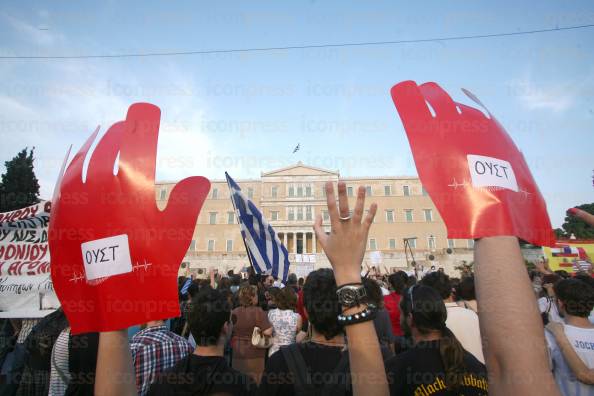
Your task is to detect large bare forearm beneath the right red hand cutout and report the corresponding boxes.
[474,236,559,395]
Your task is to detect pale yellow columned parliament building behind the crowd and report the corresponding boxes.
[156,163,473,277]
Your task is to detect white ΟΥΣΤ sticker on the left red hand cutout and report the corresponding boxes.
[81,234,132,280]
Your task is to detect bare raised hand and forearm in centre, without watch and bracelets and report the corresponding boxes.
[314,182,389,396]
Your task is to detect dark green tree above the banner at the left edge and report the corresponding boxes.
[0,148,39,212]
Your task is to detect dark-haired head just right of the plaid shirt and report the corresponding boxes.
[188,288,231,346]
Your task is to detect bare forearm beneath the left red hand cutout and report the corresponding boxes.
[95,330,138,396]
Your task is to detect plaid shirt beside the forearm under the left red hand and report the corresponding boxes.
[130,326,194,396]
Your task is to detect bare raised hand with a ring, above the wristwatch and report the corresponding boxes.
[314,182,377,286]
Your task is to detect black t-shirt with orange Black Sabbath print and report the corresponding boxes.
[386,341,489,396]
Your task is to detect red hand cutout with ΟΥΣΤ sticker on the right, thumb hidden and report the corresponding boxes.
[391,81,554,246]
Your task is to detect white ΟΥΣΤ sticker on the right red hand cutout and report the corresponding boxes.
[467,154,518,192]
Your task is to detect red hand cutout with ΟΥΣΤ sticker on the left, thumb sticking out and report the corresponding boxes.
[49,103,210,334]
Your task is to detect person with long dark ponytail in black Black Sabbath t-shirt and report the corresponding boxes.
[386,285,488,396]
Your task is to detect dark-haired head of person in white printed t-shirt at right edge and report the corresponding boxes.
[553,279,594,318]
